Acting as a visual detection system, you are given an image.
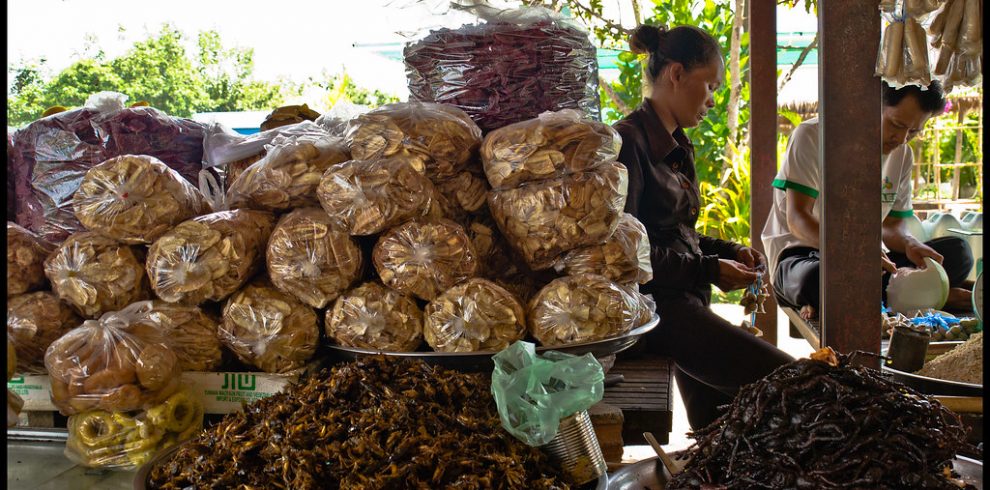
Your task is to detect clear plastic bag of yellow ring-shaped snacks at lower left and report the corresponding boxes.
[65,389,204,469]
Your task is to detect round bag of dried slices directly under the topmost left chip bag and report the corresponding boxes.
[45,231,150,318]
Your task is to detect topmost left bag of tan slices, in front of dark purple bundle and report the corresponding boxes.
[73,155,210,244]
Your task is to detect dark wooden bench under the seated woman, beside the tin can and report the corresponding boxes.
[602,354,674,445]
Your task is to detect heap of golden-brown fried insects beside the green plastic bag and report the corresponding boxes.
[149,358,570,489]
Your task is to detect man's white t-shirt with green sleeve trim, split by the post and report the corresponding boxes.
[762,118,914,273]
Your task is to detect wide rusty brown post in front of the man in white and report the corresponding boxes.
[818,1,882,367]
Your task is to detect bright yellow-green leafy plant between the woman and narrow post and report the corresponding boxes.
[697,143,751,246]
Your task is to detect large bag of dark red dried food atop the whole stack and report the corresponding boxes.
[403,8,600,131]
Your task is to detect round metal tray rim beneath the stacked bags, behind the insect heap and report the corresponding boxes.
[328,313,660,372]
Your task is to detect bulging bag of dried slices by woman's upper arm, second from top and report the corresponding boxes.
[488,162,629,270]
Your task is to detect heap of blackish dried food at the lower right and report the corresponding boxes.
[668,348,972,489]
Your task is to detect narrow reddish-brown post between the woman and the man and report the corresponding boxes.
[749,0,777,345]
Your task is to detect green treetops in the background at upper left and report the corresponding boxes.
[7,24,284,126]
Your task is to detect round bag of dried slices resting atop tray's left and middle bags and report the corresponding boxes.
[373,219,478,301]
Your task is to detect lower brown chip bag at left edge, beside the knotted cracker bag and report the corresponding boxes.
[7,291,83,374]
